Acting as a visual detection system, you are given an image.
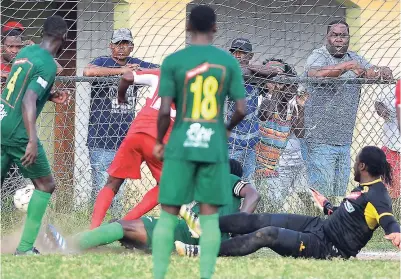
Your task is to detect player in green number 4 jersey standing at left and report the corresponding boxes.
[0,16,68,255]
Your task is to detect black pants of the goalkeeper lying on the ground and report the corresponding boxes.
[219,213,341,259]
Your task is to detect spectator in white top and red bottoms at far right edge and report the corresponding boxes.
[375,84,401,199]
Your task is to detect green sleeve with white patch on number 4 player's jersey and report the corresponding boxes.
[27,62,56,99]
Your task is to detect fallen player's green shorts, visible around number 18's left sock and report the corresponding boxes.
[141,216,199,249]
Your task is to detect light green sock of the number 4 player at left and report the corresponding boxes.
[17,190,51,252]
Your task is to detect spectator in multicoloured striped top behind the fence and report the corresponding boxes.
[255,59,301,211]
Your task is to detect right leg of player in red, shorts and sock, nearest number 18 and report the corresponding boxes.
[123,134,163,220]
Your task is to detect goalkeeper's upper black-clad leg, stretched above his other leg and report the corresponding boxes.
[219,212,322,234]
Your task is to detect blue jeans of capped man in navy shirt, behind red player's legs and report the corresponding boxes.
[89,148,125,218]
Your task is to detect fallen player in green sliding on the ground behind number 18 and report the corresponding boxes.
[46,159,260,254]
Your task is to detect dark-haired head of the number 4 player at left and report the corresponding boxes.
[42,15,68,55]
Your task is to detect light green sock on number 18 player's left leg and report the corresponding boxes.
[152,210,178,279]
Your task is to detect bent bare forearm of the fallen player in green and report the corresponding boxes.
[233,180,261,213]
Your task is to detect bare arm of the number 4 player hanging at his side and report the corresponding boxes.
[21,89,38,166]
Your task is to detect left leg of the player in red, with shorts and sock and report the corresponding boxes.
[90,134,142,229]
